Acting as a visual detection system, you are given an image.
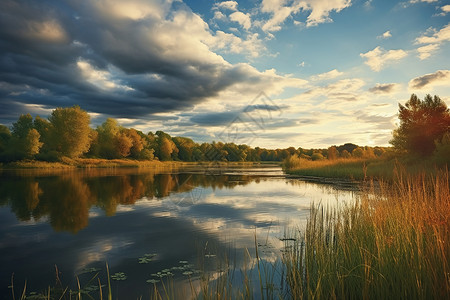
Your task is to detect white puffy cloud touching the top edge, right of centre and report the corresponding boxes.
[260,0,351,31]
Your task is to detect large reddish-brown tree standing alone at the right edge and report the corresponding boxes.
[390,94,450,156]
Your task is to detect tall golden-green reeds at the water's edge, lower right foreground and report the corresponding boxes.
[284,171,450,299]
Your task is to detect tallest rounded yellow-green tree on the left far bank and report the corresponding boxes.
[49,106,91,158]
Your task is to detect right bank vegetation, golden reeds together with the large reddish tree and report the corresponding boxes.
[283,94,450,180]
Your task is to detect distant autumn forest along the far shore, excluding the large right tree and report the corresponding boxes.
[0,106,387,162]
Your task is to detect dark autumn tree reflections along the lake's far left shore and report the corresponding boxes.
[0,169,258,233]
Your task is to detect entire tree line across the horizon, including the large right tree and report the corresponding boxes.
[0,94,450,162]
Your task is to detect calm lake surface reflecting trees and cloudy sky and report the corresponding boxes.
[0,165,354,299]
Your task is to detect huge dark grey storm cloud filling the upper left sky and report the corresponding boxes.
[0,0,268,124]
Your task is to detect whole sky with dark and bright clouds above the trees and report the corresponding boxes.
[0,0,450,148]
